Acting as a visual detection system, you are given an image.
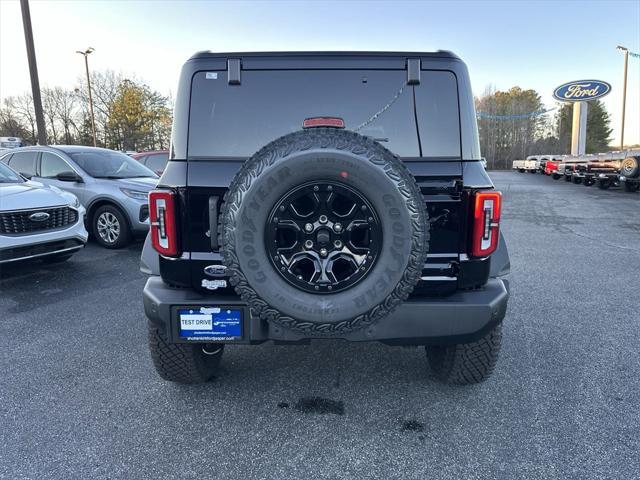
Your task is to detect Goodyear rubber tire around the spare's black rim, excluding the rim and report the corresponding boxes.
[219,128,429,336]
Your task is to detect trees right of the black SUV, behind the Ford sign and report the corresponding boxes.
[476,87,612,168]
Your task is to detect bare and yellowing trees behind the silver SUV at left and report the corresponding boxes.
[0,70,172,151]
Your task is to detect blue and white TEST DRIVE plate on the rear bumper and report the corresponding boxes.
[178,307,242,341]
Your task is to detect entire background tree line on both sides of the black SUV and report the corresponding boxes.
[0,77,611,162]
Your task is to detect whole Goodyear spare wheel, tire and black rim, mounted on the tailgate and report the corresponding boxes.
[220,128,429,335]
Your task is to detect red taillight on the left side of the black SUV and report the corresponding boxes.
[149,190,178,257]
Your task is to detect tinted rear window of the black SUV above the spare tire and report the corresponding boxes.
[188,70,460,159]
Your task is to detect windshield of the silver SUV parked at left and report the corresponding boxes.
[68,150,158,178]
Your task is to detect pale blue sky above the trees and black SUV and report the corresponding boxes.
[0,0,640,144]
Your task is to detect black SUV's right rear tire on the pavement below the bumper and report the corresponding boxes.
[425,323,502,385]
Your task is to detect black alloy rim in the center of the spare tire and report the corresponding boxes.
[265,181,382,293]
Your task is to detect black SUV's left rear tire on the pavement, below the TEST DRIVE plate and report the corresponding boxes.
[147,321,224,384]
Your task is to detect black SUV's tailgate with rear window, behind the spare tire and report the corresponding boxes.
[184,62,467,290]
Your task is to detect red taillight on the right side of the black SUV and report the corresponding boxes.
[471,191,502,257]
